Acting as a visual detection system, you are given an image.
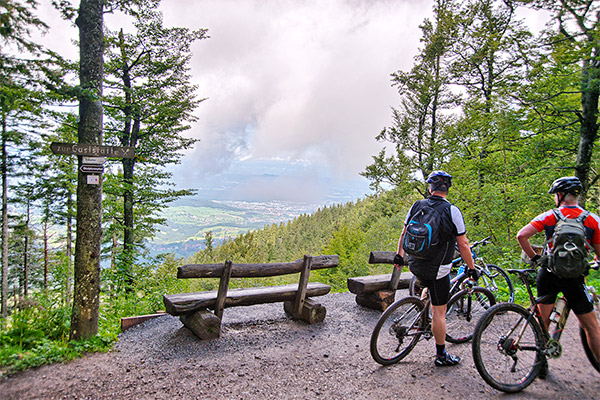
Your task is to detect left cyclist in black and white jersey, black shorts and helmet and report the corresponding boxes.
[394,171,477,367]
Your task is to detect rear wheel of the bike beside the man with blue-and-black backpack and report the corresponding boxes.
[370,297,426,365]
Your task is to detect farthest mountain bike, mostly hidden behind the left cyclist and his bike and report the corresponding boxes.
[408,237,515,303]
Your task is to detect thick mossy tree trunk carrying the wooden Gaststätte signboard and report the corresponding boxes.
[70,0,104,340]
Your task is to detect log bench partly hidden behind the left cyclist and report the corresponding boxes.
[347,251,412,311]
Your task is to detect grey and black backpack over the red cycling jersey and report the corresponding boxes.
[547,208,590,278]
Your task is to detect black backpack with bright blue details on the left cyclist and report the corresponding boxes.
[402,200,451,260]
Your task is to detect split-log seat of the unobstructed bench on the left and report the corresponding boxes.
[163,282,331,315]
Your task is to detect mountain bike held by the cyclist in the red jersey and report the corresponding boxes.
[472,268,600,393]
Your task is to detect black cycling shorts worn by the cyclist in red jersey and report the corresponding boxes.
[537,267,594,315]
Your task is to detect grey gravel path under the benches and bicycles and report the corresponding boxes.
[0,291,600,400]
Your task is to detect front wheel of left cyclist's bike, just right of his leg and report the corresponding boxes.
[446,287,496,343]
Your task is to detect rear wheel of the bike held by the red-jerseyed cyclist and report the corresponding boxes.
[472,303,546,393]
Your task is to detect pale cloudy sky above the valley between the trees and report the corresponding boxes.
[35,0,431,202]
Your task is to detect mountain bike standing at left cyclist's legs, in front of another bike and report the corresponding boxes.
[370,278,496,365]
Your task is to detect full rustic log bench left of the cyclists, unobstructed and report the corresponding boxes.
[163,255,338,339]
